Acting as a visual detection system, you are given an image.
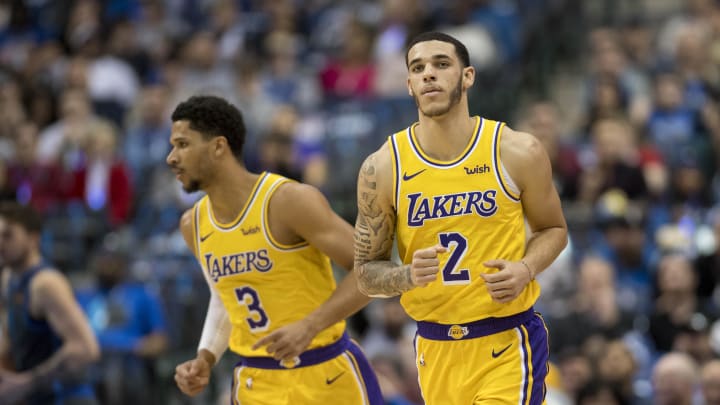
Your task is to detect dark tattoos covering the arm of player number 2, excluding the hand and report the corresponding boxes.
[355,155,414,297]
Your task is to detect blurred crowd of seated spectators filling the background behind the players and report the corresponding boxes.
[0,0,720,405]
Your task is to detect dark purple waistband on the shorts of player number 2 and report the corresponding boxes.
[417,307,535,340]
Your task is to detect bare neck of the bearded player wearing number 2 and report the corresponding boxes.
[415,105,476,161]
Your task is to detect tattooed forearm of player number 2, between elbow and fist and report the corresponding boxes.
[356,260,415,297]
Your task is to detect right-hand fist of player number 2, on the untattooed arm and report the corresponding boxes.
[480,260,531,303]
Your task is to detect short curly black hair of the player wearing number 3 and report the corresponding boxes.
[171,95,246,162]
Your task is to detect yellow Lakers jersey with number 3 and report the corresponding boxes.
[194,172,345,356]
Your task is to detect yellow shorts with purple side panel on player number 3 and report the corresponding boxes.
[231,335,384,405]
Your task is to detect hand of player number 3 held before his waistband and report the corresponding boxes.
[252,319,319,361]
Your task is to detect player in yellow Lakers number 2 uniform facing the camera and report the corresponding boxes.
[355,32,567,405]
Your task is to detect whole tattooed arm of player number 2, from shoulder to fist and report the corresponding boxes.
[355,145,445,297]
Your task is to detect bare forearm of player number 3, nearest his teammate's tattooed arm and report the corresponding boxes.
[305,271,370,333]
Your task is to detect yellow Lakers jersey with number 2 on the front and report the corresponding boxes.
[388,117,540,324]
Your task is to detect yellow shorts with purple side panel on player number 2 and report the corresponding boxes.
[415,309,549,405]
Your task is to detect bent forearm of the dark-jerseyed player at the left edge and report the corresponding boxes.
[28,343,100,387]
